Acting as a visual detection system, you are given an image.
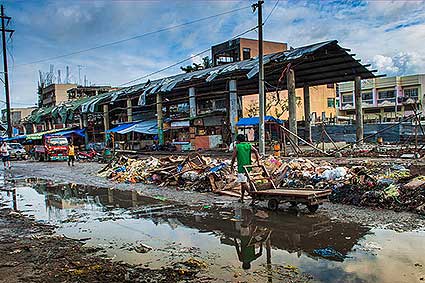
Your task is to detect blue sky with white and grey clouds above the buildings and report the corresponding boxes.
[0,0,425,107]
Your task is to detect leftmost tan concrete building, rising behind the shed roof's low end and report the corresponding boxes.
[38,84,77,107]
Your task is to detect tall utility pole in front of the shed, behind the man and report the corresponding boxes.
[252,0,266,155]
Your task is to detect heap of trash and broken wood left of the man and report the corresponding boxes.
[98,153,236,195]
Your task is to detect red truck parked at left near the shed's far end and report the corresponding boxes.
[34,136,68,161]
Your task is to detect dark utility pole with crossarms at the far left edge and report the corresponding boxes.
[0,5,14,138]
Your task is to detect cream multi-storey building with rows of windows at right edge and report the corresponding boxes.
[338,74,425,123]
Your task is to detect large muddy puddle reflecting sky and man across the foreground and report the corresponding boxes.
[0,179,425,282]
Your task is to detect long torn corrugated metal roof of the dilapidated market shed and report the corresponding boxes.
[31,40,376,119]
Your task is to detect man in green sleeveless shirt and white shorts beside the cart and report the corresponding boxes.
[230,134,260,202]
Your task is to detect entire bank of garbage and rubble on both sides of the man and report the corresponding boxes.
[99,153,425,215]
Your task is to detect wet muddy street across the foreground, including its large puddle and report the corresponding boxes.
[0,161,425,282]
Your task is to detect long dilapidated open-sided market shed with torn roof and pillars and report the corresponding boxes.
[21,40,376,150]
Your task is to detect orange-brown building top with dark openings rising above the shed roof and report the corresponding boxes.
[211,38,288,66]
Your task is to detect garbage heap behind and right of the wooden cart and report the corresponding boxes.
[264,158,425,215]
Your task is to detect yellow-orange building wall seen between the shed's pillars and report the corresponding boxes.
[242,84,337,123]
